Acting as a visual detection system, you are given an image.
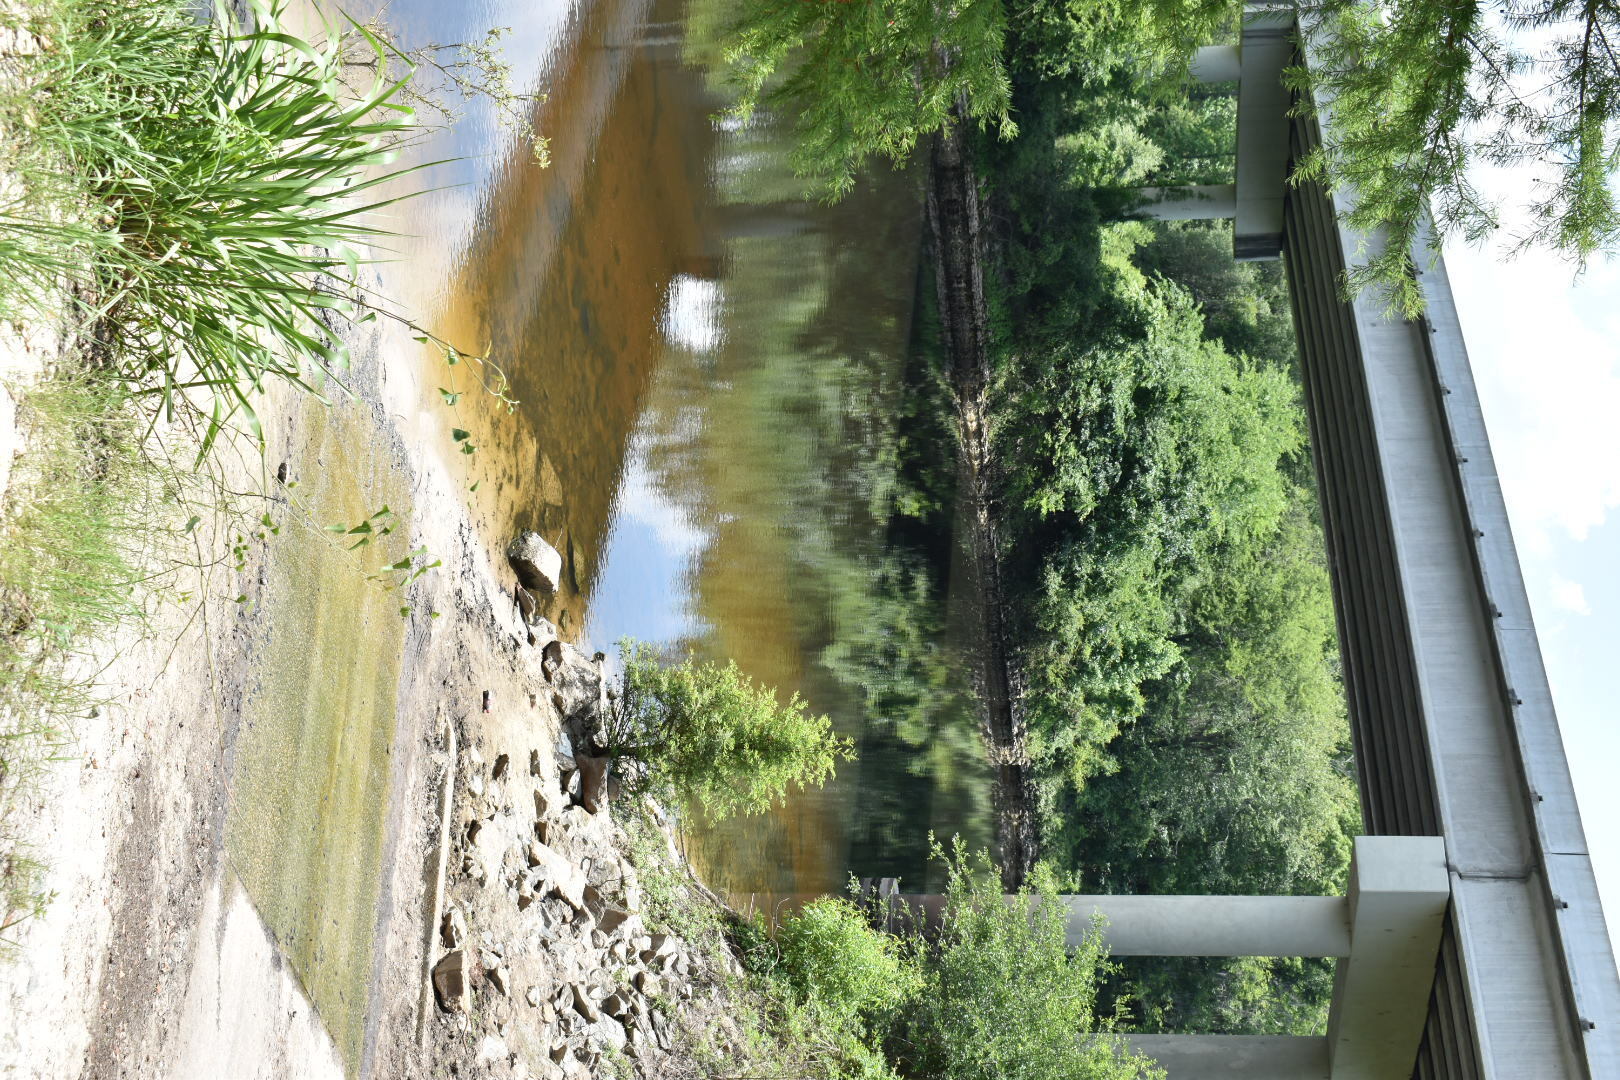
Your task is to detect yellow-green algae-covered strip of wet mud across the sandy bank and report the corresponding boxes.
[225,405,410,1070]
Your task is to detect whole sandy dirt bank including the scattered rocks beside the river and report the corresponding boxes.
[0,241,764,1080]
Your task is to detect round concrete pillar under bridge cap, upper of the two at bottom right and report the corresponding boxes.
[1063,895,1351,957]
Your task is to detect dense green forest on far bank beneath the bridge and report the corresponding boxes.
[982,55,1359,1033]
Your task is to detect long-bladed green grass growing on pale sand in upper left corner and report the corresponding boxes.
[0,0,456,939]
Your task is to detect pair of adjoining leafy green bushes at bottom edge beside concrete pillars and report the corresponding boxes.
[745,848,1163,1080]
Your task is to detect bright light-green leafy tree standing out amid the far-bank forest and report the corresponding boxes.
[1001,282,1304,784]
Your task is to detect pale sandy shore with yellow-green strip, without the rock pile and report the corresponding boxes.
[0,259,609,1078]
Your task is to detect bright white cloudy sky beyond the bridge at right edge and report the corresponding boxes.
[1445,208,1620,952]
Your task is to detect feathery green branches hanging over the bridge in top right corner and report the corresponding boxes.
[1293,0,1620,316]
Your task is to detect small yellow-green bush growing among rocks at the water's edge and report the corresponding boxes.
[611,640,854,819]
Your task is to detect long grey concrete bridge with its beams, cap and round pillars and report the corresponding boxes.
[1114,8,1620,1080]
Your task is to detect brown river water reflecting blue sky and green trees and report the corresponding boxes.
[394,0,990,892]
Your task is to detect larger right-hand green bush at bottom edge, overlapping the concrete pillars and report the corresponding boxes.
[891,848,1163,1080]
